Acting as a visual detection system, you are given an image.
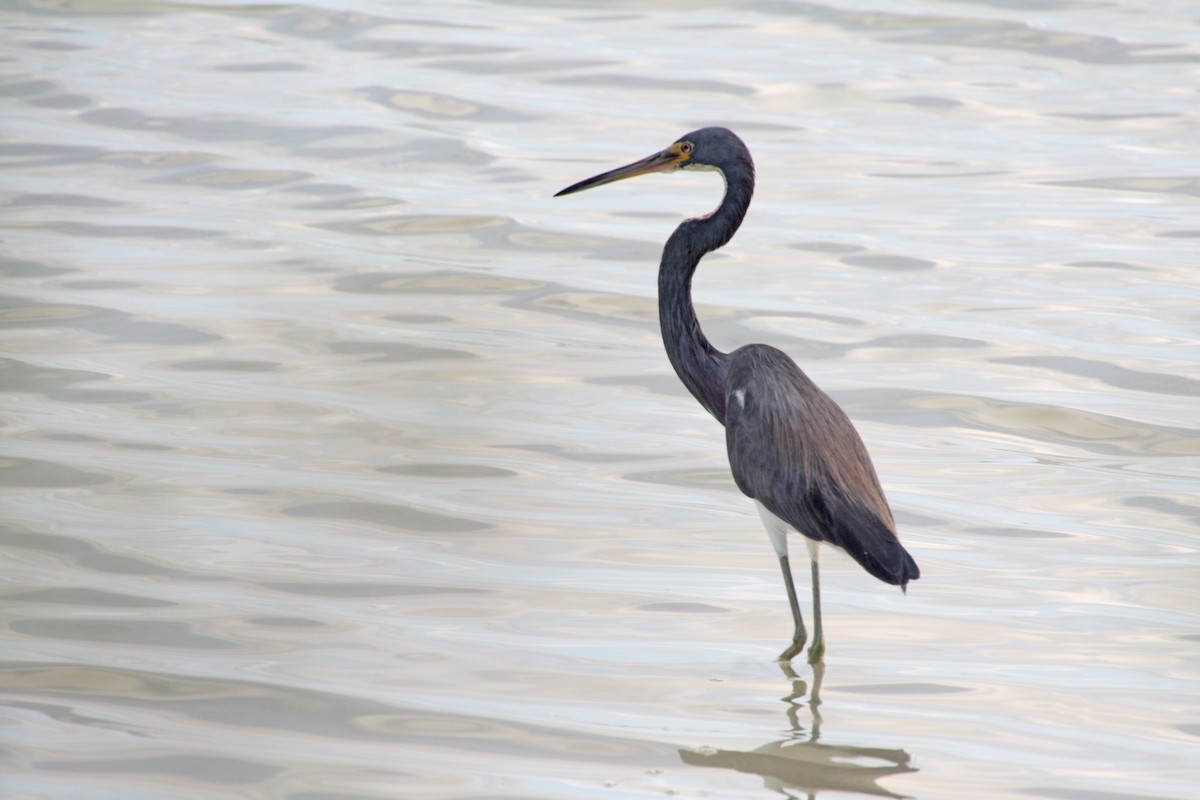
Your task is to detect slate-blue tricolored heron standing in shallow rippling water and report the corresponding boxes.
[554,127,920,663]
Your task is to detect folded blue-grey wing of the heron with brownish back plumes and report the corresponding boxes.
[725,344,918,585]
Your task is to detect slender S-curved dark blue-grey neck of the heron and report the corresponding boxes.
[659,159,754,425]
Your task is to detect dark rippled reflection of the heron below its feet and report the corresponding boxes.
[679,663,917,798]
